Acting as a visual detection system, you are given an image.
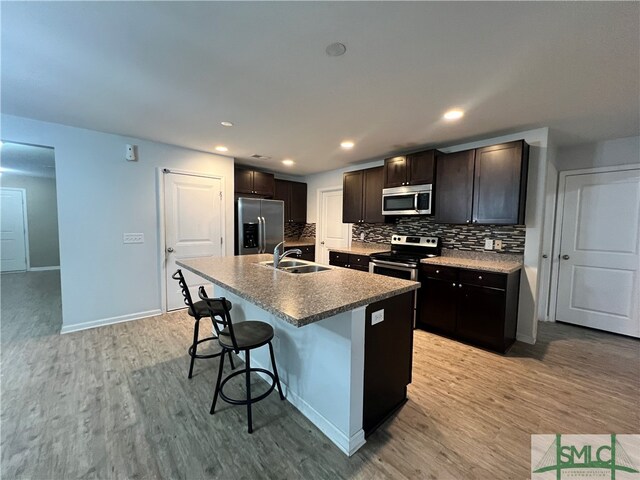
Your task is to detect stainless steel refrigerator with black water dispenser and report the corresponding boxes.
[236,197,284,255]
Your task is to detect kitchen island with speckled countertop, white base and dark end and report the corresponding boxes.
[177,255,420,455]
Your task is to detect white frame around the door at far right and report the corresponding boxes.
[549,163,640,322]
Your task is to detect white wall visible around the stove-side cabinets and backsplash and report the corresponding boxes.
[305,128,549,343]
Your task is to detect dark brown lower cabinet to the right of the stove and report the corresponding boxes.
[417,265,520,353]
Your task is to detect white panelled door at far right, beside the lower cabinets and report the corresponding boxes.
[556,169,640,337]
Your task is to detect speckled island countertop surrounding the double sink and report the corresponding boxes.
[176,254,420,327]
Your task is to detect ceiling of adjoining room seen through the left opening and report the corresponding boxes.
[0,142,56,178]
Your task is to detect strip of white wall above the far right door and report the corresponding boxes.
[557,137,640,171]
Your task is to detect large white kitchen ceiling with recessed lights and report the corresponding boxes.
[1,2,640,174]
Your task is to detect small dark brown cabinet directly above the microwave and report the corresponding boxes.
[384,150,435,188]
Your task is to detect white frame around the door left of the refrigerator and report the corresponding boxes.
[156,167,227,313]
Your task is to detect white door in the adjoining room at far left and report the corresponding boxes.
[0,188,27,272]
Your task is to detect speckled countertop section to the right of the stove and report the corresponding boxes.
[421,250,522,273]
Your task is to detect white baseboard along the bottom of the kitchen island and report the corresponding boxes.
[239,354,366,456]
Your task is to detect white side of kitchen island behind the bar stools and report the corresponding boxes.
[215,286,365,455]
